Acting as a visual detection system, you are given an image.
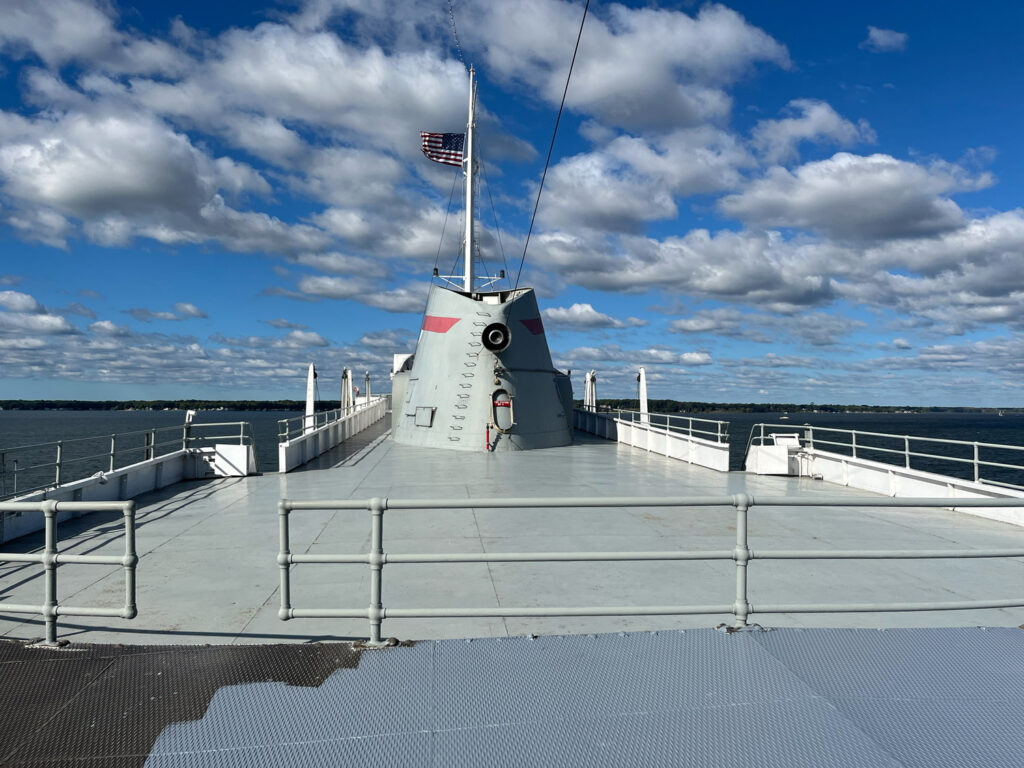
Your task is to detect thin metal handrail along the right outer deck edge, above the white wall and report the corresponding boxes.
[744,423,1024,489]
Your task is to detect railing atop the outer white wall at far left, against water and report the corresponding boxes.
[0,421,258,499]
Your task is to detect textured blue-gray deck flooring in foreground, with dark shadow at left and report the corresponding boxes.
[0,628,1024,768]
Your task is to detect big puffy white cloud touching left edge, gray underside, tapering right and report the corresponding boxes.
[0,109,327,252]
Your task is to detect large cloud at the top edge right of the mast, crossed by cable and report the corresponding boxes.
[471,1,790,129]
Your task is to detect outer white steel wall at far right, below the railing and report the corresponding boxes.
[746,445,1024,526]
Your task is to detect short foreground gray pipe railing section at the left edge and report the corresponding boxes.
[0,501,138,645]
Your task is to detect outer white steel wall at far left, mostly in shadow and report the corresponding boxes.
[0,443,256,542]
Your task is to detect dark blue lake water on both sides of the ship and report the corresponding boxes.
[0,411,1024,493]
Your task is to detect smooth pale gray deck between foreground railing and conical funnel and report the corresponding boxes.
[0,423,1024,644]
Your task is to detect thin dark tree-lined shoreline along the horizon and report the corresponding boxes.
[0,398,1024,414]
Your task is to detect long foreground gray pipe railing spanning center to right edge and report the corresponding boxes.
[278,494,1024,645]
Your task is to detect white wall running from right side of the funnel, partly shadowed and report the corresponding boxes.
[573,408,729,472]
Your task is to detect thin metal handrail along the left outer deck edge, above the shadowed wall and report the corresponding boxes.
[0,422,259,499]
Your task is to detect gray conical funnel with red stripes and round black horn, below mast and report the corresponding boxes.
[392,286,572,451]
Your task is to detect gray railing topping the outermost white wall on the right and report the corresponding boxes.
[746,424,1024,489]
